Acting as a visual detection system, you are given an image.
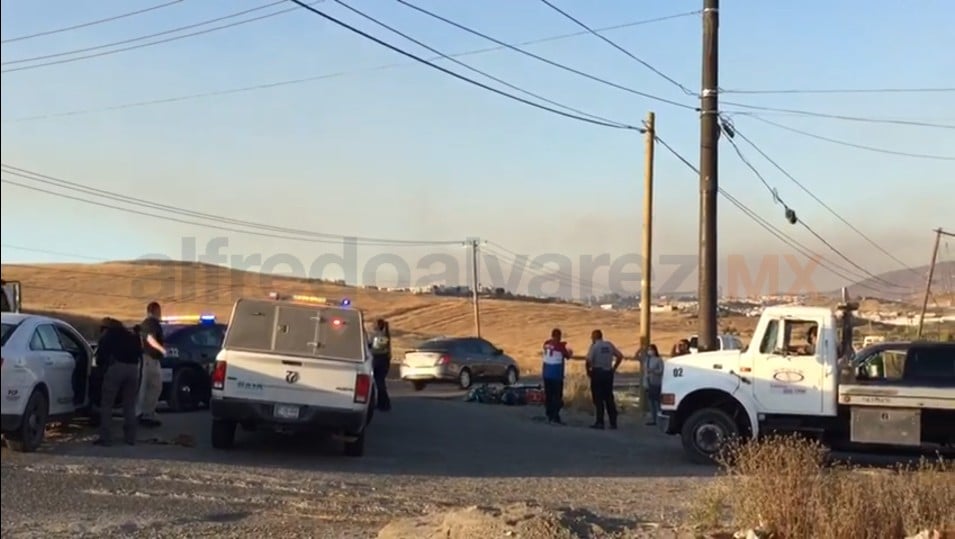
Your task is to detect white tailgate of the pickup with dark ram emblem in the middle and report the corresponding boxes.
[218,351,360,409]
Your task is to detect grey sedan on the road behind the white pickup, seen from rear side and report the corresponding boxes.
[401,337,520,391]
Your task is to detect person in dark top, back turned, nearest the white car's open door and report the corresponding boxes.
[94,318,143,445]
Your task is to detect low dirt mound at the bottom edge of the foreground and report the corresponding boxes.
[378,503,636,539]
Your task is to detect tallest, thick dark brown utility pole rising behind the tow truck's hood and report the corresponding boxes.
[699,0,720,351]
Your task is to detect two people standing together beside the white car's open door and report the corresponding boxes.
[94,301,166,445]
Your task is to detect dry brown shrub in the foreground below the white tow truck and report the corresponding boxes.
[694,437,955,539]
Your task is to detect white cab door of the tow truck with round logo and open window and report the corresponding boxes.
[752,318,830,415]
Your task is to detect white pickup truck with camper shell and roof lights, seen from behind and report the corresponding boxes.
[210,293,376,457]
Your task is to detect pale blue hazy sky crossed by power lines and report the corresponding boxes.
[0,0,955,300]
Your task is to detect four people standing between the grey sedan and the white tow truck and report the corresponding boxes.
[541,328,690,429]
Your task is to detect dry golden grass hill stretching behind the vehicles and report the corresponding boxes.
[3,261,755,371]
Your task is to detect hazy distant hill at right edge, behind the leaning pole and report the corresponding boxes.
[849,260,955,303]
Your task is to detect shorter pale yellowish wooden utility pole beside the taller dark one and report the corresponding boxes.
[640,112,656,419]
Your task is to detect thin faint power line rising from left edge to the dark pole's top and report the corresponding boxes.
[3,11,700,123]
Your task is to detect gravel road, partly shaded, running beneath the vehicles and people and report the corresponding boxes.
[0,384,713,539]
